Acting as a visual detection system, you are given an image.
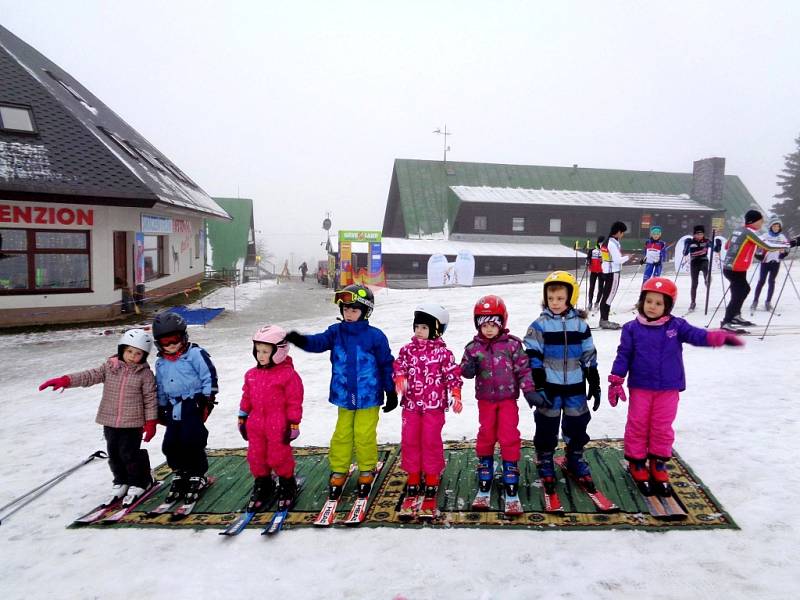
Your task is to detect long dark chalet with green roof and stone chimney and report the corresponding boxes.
[382,157,758,278]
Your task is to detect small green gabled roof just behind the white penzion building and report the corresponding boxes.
[206,198,253,269]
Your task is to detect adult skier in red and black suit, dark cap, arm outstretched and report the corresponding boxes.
[720,209,798,331]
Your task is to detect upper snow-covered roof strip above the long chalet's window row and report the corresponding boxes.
[450,185,715,213]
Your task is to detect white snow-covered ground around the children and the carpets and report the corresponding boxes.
[0,268,800,600]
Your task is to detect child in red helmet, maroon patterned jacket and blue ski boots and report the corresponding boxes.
[461,295,534,496]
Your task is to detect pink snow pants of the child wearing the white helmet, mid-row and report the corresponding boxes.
[400,409,444,477]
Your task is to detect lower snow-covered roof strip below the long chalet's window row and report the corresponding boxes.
[381,238,575,258]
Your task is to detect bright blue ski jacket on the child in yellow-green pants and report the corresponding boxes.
[303,321,394,410]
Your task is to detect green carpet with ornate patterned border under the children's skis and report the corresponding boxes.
[70,440,738,530]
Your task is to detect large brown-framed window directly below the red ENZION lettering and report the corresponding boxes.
[0,229,91,294]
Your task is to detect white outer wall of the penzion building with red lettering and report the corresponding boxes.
[0,199,205,326]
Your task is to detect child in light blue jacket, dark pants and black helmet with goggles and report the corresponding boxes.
[153,312,219,504]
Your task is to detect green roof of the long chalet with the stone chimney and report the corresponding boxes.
[384,158,757,236]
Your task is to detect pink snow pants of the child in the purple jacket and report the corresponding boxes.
[625,388,680,460]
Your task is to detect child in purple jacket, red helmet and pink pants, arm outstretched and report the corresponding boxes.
[608,277,744,496]
